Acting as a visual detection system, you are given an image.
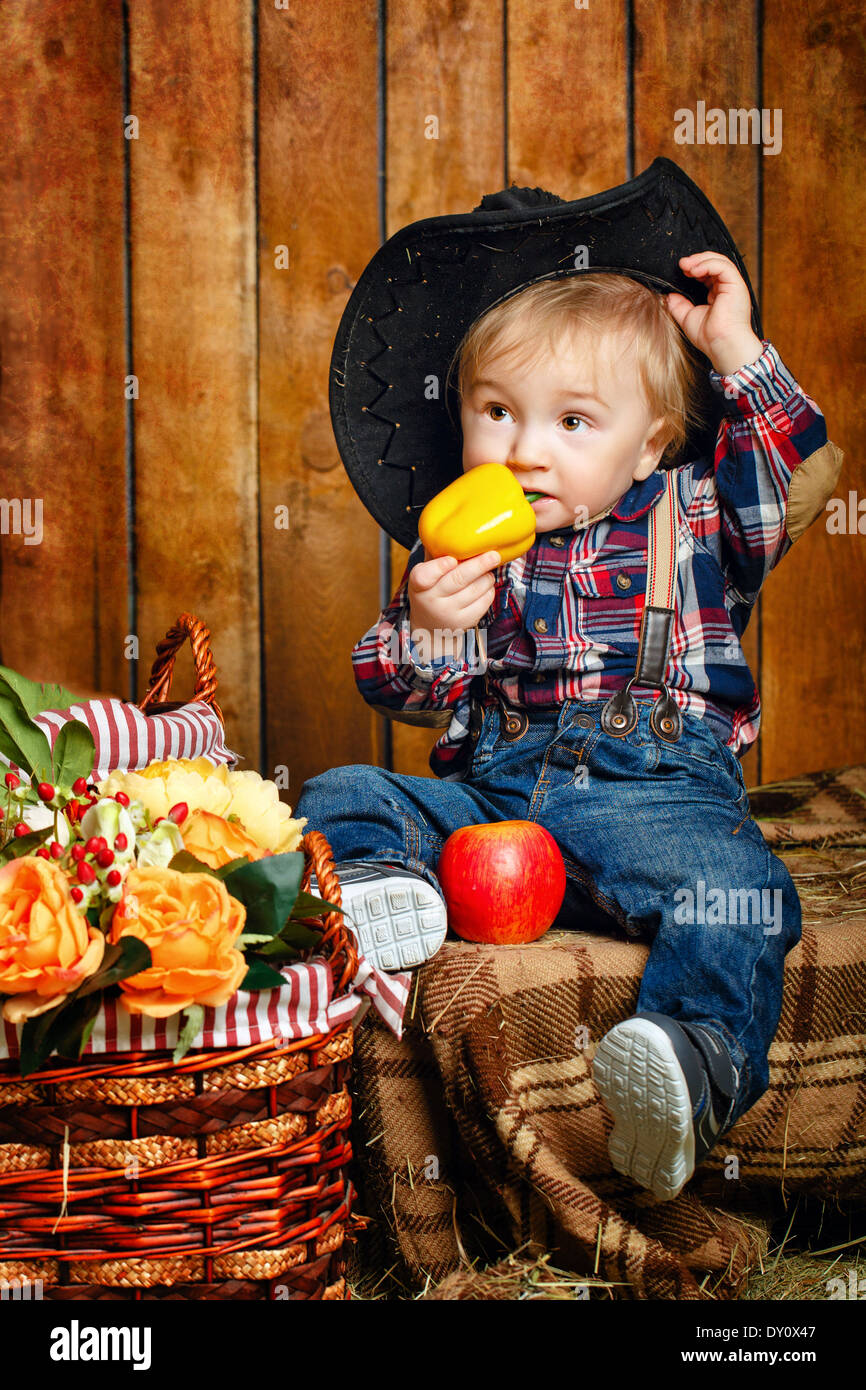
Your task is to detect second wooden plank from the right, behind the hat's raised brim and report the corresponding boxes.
[634,0,766,785]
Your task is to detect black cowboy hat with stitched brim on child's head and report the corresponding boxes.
[329,157,763,549]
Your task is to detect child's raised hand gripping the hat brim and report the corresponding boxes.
[666,252,763,375]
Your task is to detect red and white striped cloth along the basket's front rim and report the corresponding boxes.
[0,956,411,1058]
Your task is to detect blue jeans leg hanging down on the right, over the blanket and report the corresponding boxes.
[497,701,801,1119]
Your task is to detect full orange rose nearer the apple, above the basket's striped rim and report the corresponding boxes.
[108,866,247,1019]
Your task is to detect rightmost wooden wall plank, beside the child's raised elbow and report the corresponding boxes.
[763,0,866,781]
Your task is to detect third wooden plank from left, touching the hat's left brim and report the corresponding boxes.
[259,0,381,805]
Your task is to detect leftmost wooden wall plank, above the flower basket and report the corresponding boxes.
[0,8,129,706]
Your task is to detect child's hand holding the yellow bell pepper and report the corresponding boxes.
[409,550,500,656]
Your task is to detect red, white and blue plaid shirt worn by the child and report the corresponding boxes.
[352,339,827,781]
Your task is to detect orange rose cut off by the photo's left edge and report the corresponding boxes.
[0,855,106,1023]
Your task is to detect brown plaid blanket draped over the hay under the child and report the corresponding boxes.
[354,766,866,1300]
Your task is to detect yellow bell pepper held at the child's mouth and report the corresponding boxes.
[418,463,539,564]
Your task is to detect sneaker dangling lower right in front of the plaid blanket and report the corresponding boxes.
[592,1013,740,1201]
